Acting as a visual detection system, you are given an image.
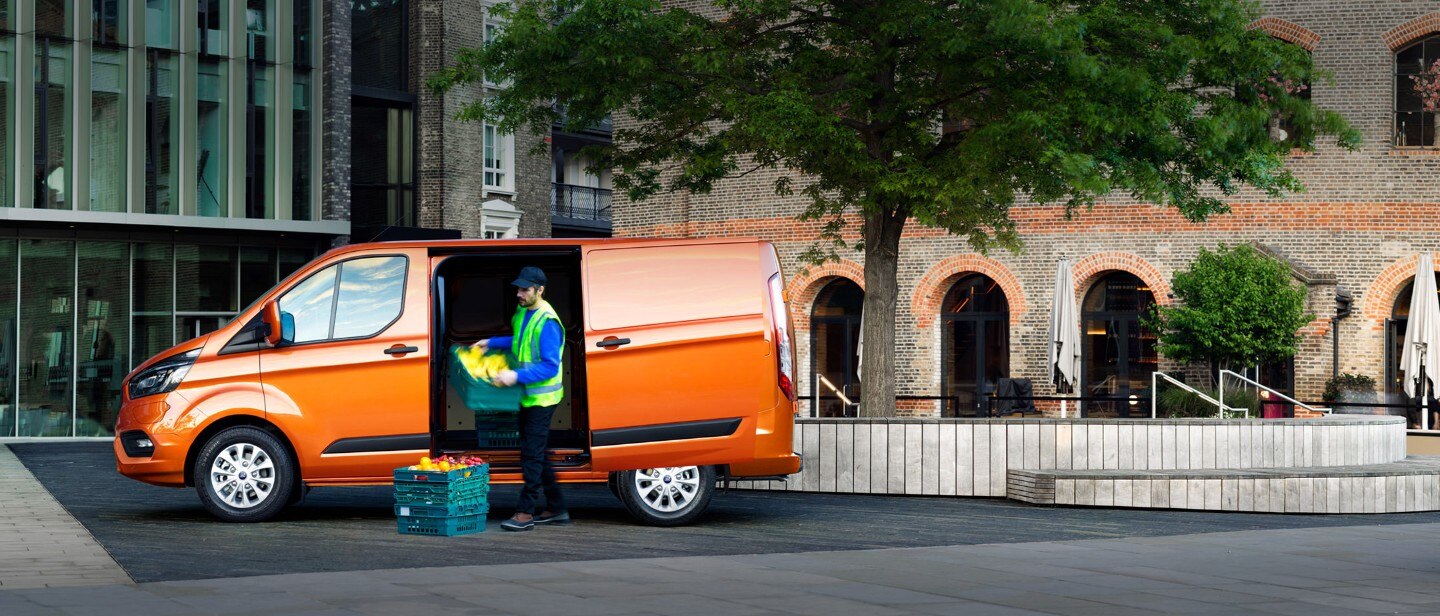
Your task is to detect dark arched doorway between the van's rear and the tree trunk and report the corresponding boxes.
[811,278,865,417]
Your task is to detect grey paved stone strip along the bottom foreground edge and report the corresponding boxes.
[0,524,1440,616]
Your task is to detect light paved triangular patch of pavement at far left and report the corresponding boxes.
[0,446,130,587]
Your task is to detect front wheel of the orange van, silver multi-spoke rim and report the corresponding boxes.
[194,426,298,522]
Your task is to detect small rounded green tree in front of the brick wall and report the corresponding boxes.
[1145,245,1315,379]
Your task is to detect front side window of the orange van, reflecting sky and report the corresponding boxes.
[279,256,406,344]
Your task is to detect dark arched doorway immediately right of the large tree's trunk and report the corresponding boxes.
[940,273,1009,417]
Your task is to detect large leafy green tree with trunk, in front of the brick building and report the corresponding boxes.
[429,0,1358,416]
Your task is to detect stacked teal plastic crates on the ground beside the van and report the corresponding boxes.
[395,463,490,537]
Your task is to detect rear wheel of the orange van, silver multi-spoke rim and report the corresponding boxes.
[611,466,716,527]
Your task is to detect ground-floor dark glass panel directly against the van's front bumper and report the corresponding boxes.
[75,242,130,436]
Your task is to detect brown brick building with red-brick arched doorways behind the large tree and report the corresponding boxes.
[615,0,1440,426]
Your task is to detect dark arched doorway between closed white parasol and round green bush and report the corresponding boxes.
[1080,272,1158,417]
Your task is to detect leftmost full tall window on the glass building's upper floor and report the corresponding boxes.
[35,39,73,209]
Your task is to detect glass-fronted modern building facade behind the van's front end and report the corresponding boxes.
[0,0,331,436]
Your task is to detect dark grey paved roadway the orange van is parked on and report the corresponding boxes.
[14,442,1440,587]
